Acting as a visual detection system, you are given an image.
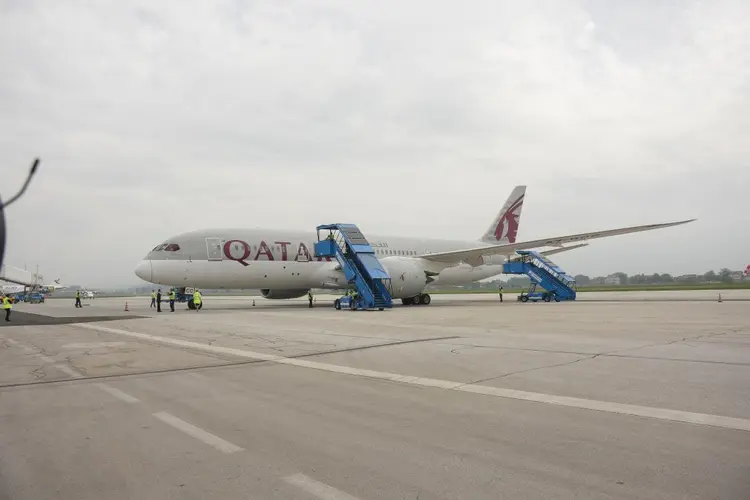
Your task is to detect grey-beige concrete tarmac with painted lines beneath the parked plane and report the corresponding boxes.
[0,290,750,500]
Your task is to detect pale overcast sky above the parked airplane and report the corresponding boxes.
[0,0,750,287]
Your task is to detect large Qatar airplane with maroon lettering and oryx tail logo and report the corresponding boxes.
[134,186,696,305]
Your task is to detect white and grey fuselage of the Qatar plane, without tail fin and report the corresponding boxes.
[136,229,505,298]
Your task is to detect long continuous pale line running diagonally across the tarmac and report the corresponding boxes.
[71,323,750,432]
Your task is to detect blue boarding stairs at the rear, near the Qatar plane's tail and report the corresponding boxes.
[503,250,576,302]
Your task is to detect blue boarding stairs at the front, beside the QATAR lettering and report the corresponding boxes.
[315,224,393,311]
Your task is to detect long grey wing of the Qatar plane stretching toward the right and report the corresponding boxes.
[420,219,696,266]
